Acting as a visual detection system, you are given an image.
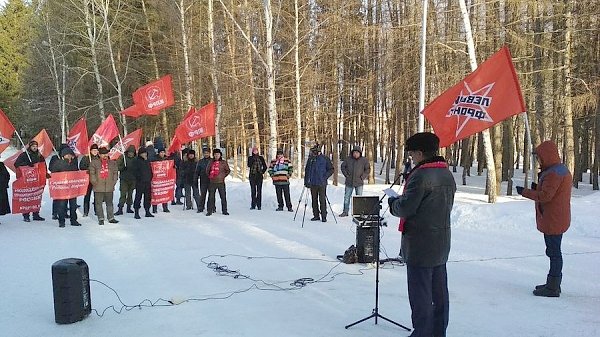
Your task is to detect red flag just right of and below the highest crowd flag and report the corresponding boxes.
[175,102,215,143]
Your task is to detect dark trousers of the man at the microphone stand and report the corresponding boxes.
[406,264,450,337]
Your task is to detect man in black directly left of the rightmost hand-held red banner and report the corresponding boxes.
[131,147,154,219]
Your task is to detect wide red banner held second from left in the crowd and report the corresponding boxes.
[48,171,90,200]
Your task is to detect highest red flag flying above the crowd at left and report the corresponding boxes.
[133,75,175,116]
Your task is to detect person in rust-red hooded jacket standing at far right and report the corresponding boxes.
[517,141,573,297]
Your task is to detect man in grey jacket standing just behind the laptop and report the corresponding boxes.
[340,146,371,217]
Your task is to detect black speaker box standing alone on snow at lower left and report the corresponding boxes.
[52,258,92,324]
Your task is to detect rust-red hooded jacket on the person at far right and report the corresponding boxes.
[523,141,573,235]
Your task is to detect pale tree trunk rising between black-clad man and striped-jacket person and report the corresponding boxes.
[264,0,277,158]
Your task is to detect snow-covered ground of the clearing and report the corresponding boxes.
[0,153,600,337]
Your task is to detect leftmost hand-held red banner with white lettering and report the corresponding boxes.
[12,163,46,214]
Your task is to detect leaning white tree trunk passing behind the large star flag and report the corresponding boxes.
[459,0,496,203]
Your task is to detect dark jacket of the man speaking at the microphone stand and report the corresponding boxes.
[389,157,456,267]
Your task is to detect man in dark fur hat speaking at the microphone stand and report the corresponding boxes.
[388,132,456,337]
